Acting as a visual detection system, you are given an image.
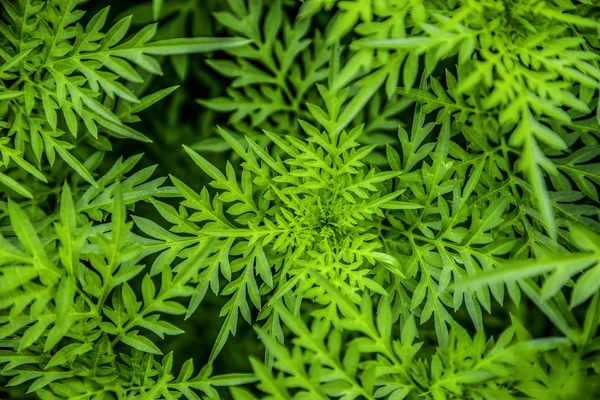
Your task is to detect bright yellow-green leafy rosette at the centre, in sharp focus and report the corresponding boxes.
[141,83,420,358]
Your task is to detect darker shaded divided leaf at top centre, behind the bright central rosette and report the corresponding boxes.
[194,0,408,155]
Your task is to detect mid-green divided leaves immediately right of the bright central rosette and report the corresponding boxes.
[382,103,521,345]
